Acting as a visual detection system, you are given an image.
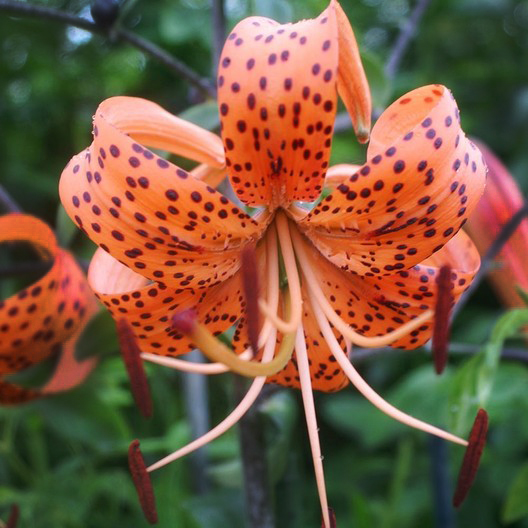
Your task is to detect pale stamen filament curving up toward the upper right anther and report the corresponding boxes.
[292,230,434,348]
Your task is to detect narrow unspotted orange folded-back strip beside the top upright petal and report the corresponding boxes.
[331,0,372,143]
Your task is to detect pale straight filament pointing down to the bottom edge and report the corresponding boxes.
[295,325,330,528]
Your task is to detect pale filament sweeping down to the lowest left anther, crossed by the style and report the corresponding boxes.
[143,329,277,472]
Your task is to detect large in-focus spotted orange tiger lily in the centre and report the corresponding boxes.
[60,0,486,528]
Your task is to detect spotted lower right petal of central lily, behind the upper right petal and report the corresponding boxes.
[304,231,480,349]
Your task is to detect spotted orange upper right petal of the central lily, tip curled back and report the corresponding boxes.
[300,86,486,276]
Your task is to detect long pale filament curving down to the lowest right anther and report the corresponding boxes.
[309,291,468,446]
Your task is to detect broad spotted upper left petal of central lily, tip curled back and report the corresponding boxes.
[60,98,265,287]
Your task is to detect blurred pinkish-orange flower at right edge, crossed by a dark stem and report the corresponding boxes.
[466,141,528,307]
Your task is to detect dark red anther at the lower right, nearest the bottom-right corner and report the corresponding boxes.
[453,409,488,508]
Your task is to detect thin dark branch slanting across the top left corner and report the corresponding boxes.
[0,0,216,98]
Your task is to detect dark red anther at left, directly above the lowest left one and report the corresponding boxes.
[116,319,152,418]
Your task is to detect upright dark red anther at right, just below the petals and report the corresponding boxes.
[433,265,453,374]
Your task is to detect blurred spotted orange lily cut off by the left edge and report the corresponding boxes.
[0,213,97,404]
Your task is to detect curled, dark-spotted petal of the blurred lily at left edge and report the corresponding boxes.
[0,214,95,375]
